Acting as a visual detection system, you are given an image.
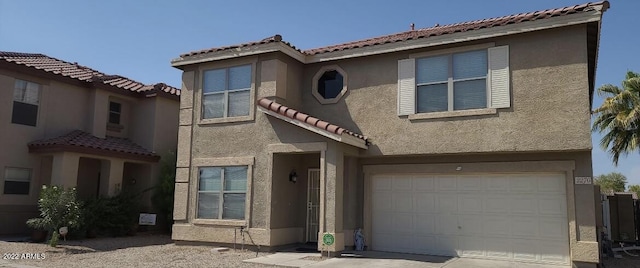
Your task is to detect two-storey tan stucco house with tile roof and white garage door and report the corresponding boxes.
[172,2,609,267]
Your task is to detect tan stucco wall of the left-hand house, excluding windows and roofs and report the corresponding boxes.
[0,69,179,233]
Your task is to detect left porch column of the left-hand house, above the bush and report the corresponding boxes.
[51,152,80,188]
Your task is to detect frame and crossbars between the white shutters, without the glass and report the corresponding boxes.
[415,48,491,114]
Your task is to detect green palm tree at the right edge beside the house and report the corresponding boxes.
[592,71,640,165]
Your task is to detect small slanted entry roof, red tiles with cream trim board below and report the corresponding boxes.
[258,98,369,149]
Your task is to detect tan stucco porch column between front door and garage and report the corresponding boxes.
[318,142,345,252]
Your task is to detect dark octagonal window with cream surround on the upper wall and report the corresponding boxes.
[313,65,347,104]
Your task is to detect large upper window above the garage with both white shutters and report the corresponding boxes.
[398,46,511,116]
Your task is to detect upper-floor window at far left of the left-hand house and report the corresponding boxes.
[11,79,40,127]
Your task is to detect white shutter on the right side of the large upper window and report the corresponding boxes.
[489,46,511,108]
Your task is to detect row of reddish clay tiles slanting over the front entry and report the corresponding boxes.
[258,98,369,145]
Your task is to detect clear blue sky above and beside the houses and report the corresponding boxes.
[0,0,640,184]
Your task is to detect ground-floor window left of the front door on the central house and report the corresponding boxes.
[197,166,248,220]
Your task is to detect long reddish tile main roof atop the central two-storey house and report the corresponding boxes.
[180,1,609,57]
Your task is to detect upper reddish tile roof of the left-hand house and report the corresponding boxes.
[0,51,180,96]
